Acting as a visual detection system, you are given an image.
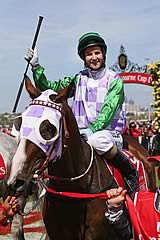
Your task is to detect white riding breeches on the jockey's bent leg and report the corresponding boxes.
[81,130,123,155]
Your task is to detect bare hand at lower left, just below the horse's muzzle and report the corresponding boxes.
[3,196,19,217]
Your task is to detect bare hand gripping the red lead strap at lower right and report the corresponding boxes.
[107,187,127,207]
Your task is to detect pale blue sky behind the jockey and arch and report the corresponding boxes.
[0,0,160,113]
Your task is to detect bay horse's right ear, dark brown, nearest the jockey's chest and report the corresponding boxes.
[55,82,74,103]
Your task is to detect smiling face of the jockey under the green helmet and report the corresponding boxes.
[84,46,104,70]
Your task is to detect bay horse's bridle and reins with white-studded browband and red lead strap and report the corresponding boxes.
[19,97,112,216]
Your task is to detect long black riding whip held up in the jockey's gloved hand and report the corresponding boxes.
[12,16,43,113]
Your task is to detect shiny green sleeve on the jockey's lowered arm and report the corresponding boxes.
[90,78,124,132]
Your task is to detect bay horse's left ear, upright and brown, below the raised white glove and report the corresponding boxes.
[24,74,41,99]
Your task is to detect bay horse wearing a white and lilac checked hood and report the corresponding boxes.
[8,76,150,240]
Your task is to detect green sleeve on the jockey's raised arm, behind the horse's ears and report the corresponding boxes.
[33,66,78,91]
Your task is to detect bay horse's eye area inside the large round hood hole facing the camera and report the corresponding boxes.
[39,120,57,140]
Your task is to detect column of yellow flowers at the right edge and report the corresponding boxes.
[147,61,160,132]
